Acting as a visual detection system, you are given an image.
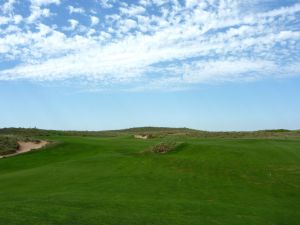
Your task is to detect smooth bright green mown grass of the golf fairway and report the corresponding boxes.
[0,135,300,225]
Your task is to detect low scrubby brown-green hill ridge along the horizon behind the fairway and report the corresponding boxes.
[0,127,300,138]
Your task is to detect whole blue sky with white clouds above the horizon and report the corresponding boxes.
[0,0,300,131]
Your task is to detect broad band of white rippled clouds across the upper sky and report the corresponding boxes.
[0,0,300,89]
